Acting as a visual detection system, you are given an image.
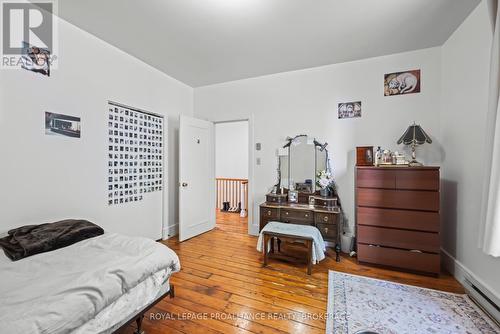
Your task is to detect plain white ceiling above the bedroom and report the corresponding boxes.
[53,0,480,87]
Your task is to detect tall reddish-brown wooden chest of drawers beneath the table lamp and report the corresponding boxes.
[356,167,440,275]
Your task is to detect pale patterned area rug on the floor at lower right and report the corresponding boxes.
[326,270,500,334]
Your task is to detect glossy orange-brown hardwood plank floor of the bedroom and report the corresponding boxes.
[126,213,463,334]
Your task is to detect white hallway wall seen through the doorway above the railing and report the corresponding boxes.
[215,121,248,179]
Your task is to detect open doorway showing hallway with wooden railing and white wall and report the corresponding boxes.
[215,120,249,234]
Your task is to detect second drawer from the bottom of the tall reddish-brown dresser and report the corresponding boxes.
[358,225,439,253]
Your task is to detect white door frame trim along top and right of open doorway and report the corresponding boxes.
[213,114,259,235]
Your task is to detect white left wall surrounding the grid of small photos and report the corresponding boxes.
[0,20,193,239]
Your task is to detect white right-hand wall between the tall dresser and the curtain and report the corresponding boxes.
[441,0,500,299]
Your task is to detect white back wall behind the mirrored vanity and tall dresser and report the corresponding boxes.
[194,48,443,233]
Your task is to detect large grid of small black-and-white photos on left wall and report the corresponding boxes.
[108,102,164,205]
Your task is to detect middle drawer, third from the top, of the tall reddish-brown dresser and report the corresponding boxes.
[357,207,439,232]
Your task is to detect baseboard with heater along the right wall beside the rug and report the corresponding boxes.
[441,248,500,322]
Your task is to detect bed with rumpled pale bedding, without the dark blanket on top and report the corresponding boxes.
[0,233,180,334]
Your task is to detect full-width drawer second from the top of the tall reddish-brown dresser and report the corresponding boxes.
[357,188,439,211]
